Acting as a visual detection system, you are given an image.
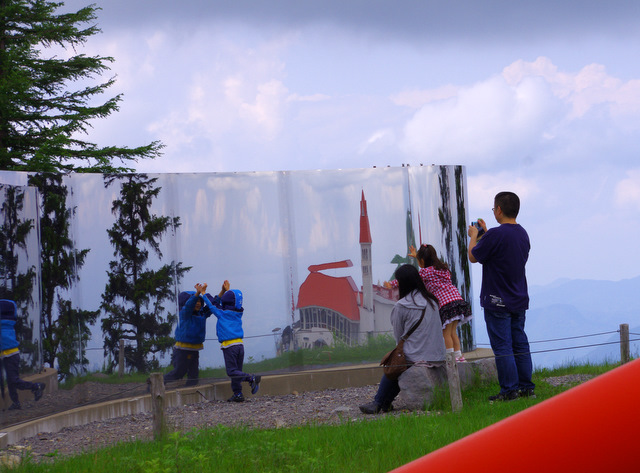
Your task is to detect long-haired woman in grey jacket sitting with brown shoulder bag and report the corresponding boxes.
[360,264,445,414]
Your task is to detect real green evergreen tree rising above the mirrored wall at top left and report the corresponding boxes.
[0,0,162,172]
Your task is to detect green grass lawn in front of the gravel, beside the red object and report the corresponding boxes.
[2,364,617,473]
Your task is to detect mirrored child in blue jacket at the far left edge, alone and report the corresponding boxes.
[0,299,45,411]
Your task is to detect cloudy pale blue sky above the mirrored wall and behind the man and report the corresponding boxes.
[55,0,640,288]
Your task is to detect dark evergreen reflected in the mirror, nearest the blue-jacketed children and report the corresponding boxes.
[100,174,191,371]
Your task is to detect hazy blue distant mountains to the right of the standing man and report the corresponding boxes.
[475,276,640,368]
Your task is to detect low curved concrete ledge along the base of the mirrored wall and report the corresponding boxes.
[0,349,493,448]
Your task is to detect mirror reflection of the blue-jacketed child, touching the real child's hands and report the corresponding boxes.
[164,284,211,386]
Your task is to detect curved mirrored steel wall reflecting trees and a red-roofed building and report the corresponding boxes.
[0,166,475,374]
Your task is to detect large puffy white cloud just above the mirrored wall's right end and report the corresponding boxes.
[401,76,557,168]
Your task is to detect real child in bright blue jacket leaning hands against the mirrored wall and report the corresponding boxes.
[205,280,262,402]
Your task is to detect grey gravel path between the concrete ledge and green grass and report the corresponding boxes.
[3,375,592,461]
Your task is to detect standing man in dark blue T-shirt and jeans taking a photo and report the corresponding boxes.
[468,192,535,401]
